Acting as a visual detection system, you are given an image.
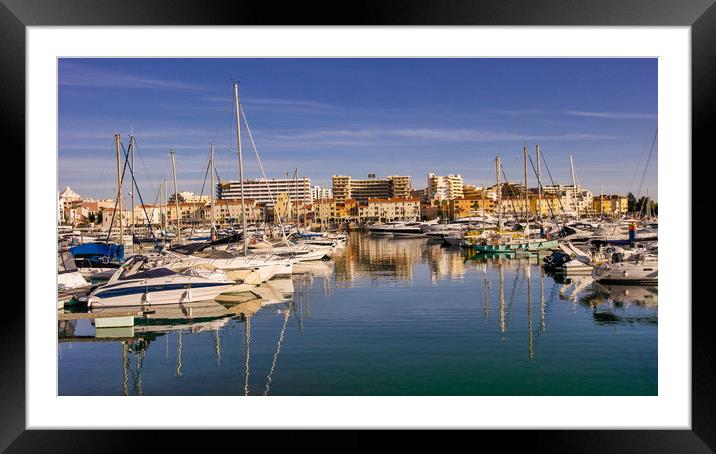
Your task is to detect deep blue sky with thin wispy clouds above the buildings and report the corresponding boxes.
[58,59,658,203]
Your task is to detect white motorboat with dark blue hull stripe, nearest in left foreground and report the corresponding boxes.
[86,255,235,308]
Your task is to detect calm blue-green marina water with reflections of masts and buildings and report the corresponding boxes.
[58,234,658,395]
